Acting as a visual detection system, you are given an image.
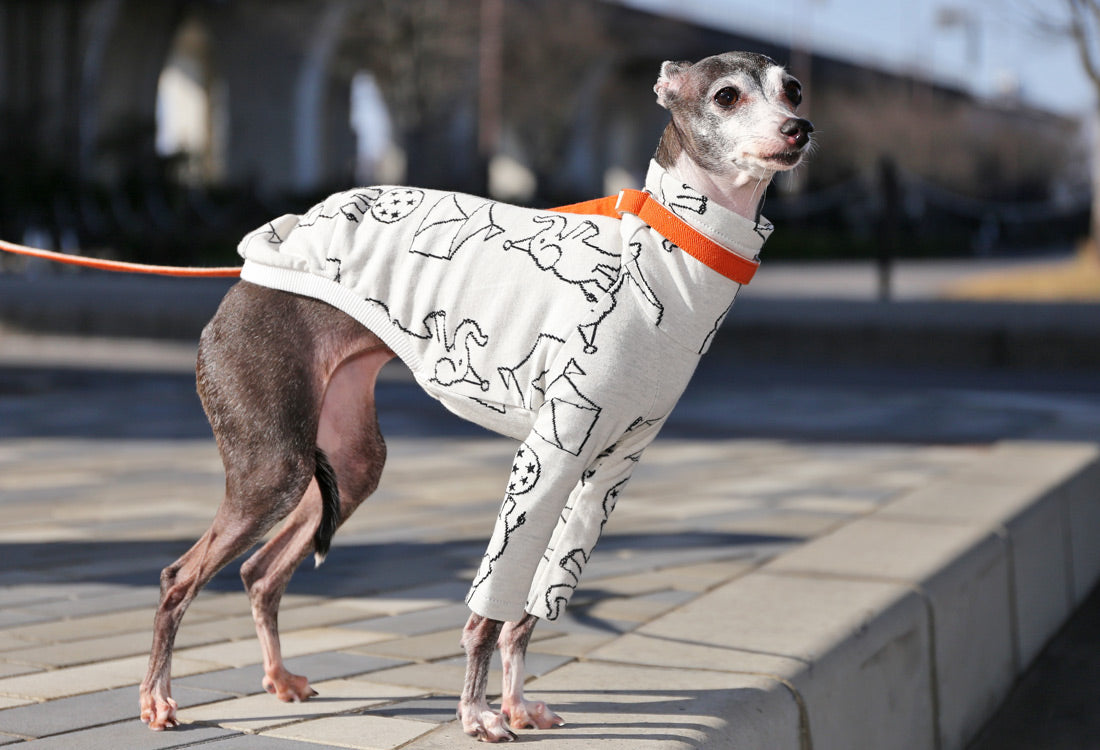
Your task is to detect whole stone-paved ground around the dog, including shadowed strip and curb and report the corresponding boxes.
[0,327,1100,750]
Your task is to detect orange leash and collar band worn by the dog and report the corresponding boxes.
[0,190,760,284]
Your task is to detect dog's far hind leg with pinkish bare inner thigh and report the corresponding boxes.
[241,340,393,702]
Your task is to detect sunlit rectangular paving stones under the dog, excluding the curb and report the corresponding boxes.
[0,428,983,748]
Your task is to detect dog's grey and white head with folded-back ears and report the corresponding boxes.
[653,52,814,178]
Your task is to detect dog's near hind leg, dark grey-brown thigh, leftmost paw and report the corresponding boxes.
[141,283,341,729]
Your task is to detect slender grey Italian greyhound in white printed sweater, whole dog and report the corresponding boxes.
[141,53,813,742]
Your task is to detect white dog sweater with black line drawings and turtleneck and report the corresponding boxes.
[239,163,771,620]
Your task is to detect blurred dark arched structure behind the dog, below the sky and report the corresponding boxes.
[0,0,1088,259]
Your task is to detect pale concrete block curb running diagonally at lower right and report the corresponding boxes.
[523,442,1100,750]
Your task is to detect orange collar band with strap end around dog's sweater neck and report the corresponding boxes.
[552,190,760,284]
